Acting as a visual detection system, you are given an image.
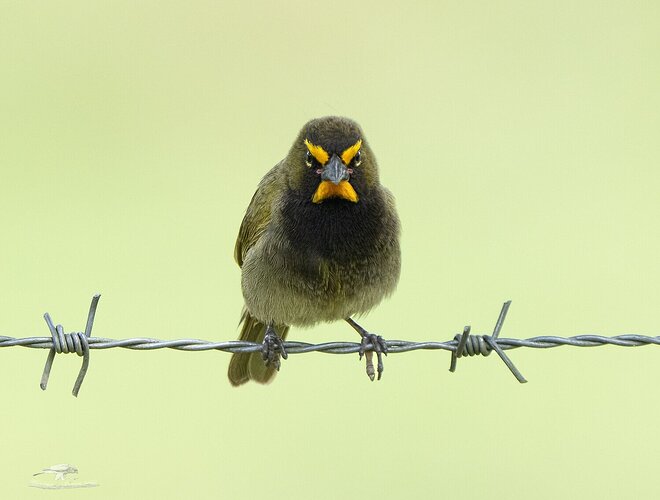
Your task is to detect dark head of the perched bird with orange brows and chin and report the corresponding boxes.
[286,116,378,204]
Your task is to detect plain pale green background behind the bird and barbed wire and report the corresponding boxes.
[0,1,660,500]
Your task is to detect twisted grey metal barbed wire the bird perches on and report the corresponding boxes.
[0,294,660,397]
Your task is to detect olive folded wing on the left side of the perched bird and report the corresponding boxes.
[234,162,282,266]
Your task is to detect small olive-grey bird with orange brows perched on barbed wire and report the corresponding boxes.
[228,116,401,386]
